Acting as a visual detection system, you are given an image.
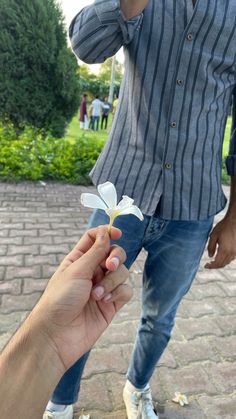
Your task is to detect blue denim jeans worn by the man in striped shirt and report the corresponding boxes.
[52,210,213,404]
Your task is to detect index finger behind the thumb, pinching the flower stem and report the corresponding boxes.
[59,225,122,270]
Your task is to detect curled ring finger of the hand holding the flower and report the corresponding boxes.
[91,265,129,301]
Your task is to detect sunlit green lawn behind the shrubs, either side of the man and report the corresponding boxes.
[66,115,231,184]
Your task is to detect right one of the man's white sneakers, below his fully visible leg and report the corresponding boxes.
[123,387,158,419]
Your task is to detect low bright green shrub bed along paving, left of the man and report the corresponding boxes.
[0,126,104,185]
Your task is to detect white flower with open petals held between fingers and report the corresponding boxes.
[81,182,143,229]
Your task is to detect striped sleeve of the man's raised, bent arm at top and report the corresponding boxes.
[69,0,142,64]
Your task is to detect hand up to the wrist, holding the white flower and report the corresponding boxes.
[29,226,132,370]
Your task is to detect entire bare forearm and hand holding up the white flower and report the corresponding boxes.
[0,226,132,419]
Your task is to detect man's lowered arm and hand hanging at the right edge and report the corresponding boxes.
[206,87,236,269]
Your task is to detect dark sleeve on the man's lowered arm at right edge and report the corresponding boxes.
[225,86,236,176]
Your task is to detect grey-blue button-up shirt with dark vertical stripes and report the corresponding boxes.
[70,0,236,220]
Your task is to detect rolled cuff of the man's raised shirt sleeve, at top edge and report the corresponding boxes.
[95,0,143,44]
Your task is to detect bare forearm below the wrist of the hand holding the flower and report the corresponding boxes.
[0,319,64,419]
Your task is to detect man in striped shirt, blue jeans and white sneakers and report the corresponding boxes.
[43,0,236,419]
